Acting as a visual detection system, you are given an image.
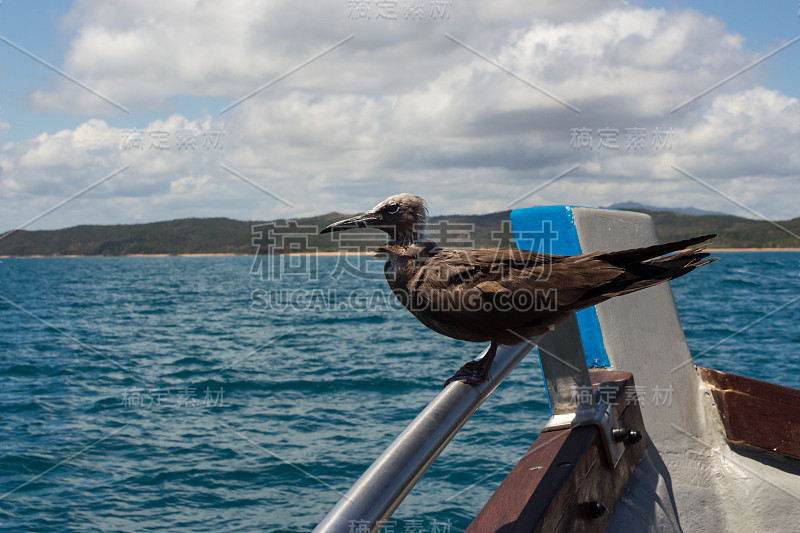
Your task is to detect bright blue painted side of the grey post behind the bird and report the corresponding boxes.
[511,205,611,368]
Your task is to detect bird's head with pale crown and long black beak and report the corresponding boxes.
[320,193,428,244]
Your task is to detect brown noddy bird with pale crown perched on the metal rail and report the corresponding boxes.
[320,194,717,385]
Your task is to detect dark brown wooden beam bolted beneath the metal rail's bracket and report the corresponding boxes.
[467,370,647,533]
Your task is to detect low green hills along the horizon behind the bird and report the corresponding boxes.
[0,203,800,256]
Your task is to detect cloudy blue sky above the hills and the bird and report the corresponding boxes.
[0,0,800,229]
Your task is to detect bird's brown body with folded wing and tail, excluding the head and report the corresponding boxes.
[386,236,713,344]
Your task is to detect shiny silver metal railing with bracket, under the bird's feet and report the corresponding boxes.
[314,315,608,533]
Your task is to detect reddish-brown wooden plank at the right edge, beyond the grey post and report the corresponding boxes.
[697,367,800,458]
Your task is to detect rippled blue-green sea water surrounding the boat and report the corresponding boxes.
[0,252,800,532]
